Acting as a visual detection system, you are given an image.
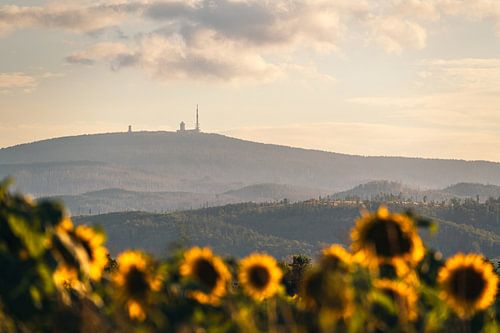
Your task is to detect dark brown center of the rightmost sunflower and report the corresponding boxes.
[450,267,486,301]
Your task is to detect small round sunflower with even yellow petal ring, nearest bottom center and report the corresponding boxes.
[238,253,283,300]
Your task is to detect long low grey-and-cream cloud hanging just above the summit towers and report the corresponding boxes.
[66,30,282,81]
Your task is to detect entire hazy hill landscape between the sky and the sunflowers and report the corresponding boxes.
[0,132,500,257]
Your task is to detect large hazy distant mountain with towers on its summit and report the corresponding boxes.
[0,132,500,196]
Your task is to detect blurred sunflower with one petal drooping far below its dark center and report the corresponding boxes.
[113,251,162,320]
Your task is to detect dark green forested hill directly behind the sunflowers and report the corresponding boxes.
[75,201,500,258]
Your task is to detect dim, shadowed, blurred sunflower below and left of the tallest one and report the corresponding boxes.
[300,267,354,319]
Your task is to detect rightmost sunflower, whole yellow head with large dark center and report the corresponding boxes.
[438,253,499,319]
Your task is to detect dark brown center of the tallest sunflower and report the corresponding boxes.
[366,220,411,258]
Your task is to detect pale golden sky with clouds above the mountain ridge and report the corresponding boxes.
[0,0,500,162]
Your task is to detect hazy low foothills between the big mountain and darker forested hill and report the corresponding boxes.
[44,180,496,215]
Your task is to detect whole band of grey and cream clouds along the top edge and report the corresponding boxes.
[4,0,500,81]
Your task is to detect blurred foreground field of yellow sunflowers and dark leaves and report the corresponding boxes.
[0,181,500,333]
